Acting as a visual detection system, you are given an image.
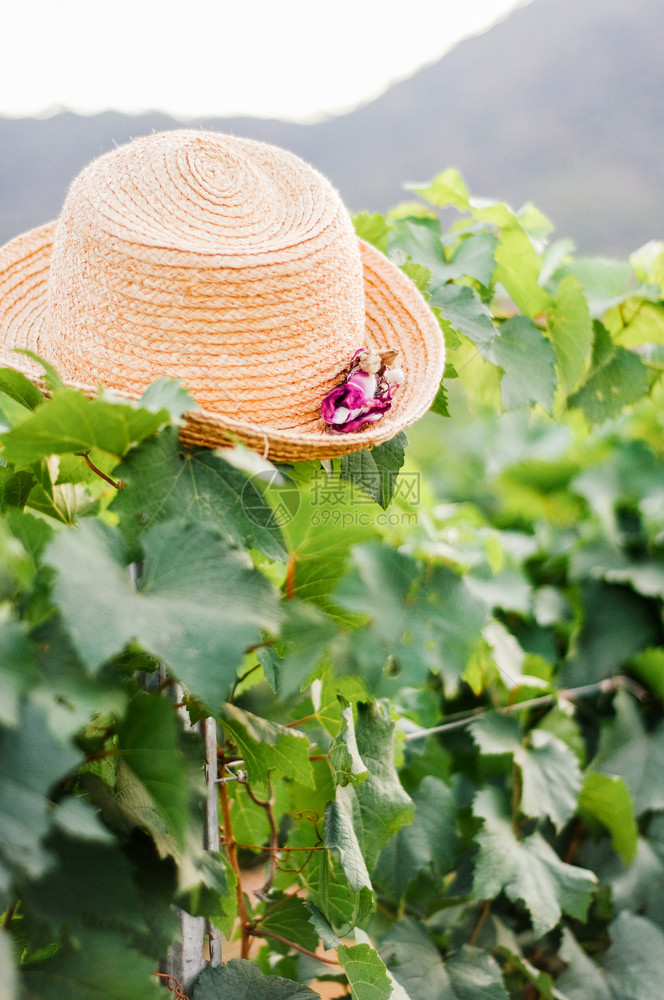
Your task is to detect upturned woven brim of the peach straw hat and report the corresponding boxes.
[0,222,445,462]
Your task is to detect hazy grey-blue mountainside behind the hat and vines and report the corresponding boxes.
[0,0,664,254]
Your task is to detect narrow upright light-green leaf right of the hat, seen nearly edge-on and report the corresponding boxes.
[547,275,593,396]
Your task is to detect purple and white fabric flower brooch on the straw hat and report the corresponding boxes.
[321,347,404,433]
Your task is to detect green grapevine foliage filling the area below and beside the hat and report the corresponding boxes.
[0,170,664,1000]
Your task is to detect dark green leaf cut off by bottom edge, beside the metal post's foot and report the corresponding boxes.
[192,958,318,1000]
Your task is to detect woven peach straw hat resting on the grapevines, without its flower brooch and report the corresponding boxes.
[0,130,444,461]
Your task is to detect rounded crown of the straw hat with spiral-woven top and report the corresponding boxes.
[42,130,365,429]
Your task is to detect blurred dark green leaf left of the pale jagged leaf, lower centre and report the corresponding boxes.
[373,775,458,904]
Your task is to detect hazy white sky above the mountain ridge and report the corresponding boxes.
[0,0,524,120]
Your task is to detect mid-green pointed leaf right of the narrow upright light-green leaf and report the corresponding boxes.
[568,323,648,423]
